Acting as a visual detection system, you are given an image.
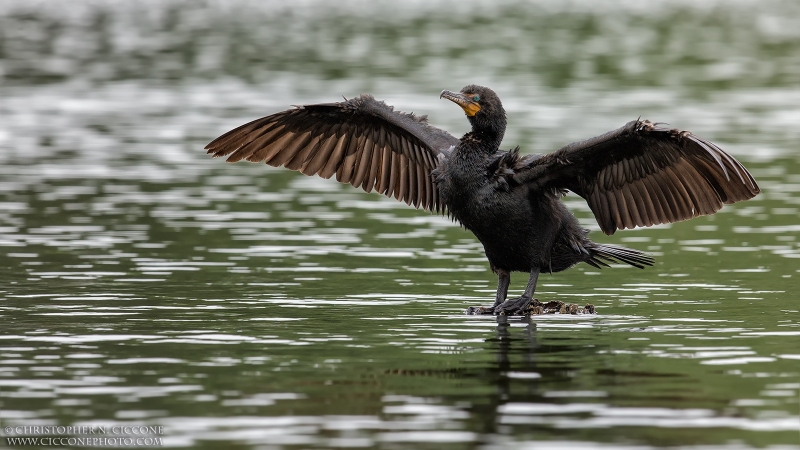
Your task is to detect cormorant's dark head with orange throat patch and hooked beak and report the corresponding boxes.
[439,84,506,142]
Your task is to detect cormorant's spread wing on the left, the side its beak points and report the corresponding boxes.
[206,95,458,212]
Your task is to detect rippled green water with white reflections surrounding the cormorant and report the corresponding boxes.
[0,1,800,450]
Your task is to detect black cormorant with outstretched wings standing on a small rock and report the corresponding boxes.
[206,85,760,314]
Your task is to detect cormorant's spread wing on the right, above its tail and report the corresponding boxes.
[513,120,760,234]
